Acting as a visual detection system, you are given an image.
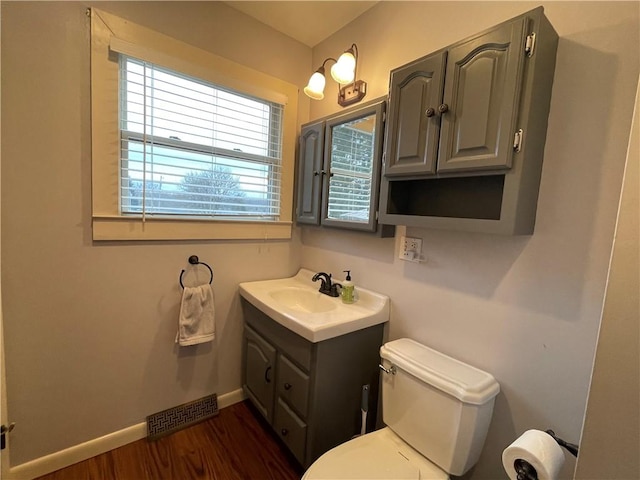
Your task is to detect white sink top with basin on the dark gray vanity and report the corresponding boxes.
[240,268,389,343]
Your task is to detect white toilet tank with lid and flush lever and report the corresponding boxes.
[380,338,500,476]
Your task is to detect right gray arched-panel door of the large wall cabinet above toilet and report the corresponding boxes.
[438,18,527,172]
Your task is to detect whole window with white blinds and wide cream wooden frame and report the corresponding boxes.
[91,8,298,240]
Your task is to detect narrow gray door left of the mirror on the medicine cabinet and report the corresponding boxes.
[296,122,324,225]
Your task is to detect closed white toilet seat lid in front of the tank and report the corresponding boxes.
[302,427,449,480]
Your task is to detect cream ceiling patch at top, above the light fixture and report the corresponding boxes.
[224,1,378,47]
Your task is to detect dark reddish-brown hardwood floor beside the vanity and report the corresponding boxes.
[37,402,303,480]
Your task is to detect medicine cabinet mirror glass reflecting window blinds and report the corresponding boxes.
[328,124,375,223]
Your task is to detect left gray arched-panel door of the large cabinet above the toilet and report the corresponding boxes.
[384,52,447,177]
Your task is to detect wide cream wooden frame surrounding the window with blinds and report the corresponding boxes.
[90,8,298,240]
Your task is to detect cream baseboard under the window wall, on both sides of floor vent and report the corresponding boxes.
[6,388,245,480]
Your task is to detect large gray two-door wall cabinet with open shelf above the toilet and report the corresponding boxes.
[380,7,558,234]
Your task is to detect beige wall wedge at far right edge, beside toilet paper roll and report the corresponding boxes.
[576,80,640,480]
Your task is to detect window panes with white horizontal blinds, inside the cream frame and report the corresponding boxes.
[120,55,283,220]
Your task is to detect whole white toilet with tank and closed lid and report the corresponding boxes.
[302,338,500,480]
